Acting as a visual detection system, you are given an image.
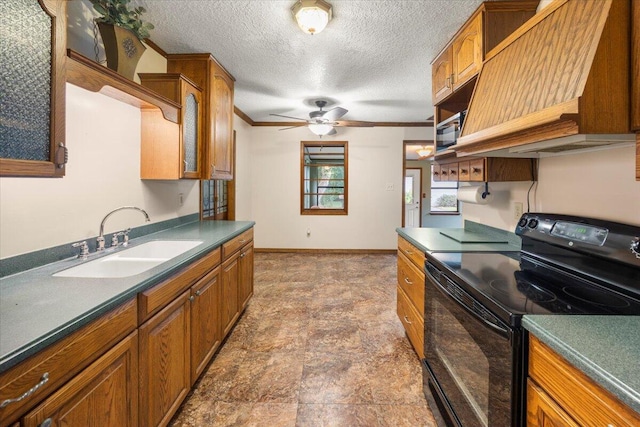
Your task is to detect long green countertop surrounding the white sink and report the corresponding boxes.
[0,221,255,373]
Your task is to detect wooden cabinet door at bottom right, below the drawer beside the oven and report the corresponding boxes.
[527,380,578,427]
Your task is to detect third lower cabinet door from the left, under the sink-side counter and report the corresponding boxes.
[191,267,221,385]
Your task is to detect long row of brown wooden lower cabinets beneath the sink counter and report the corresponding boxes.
[0,230,253,427]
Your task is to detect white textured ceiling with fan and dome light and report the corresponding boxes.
[132,0,481,122]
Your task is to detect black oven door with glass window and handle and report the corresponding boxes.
[424,264,519,427]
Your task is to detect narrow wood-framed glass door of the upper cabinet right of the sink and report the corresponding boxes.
[180,82,204,179]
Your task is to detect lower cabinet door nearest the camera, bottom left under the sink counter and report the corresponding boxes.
[22,331,138,427]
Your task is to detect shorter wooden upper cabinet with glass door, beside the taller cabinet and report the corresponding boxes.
[138,73,204,179]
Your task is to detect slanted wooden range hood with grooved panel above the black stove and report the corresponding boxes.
[453,0,635,157]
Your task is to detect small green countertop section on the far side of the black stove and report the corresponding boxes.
[396,220,521,252]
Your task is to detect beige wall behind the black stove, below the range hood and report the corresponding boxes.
[462,147,640,231]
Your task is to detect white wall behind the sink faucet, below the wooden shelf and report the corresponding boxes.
[0,84,199,258]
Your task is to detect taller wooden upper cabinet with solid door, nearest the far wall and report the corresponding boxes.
[167,53,235,180]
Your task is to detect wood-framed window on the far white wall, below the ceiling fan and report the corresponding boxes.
[300,141,349,215]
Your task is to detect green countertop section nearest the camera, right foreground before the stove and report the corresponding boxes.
[522,315,640,413]
